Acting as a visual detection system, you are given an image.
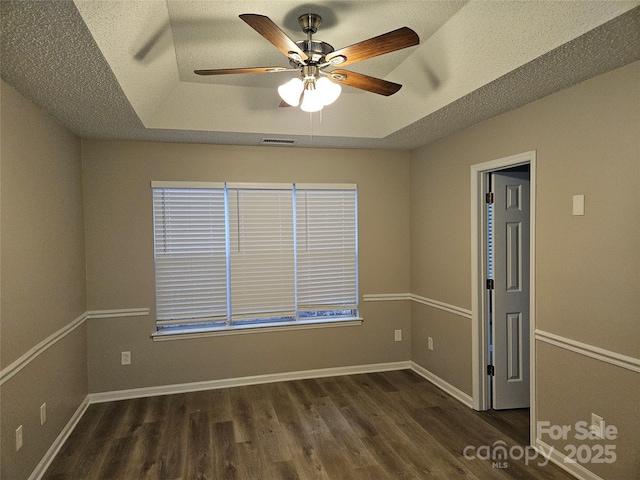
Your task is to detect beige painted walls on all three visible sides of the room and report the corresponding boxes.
[0,58,640,478]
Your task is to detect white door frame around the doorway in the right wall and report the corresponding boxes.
[471,150,536,432]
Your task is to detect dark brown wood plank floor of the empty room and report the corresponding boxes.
[44,370,572,480]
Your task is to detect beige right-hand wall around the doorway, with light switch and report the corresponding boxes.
[411,63,640,478]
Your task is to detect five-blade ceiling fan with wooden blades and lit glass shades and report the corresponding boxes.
[194,13,420,112]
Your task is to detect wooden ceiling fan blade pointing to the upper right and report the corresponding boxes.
[325,27,420,66]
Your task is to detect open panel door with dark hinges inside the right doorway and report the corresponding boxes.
[492,171,530,410]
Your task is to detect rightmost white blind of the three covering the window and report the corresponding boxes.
[296,184,358,315]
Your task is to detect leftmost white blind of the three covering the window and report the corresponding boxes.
[153,186,227,326]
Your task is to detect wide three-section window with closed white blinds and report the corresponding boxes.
[151,182,358,334]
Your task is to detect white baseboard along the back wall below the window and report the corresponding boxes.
[88,361,411,403]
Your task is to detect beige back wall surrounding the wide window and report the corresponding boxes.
[83,140,410,392]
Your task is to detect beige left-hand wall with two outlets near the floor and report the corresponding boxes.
[0,82,87,479]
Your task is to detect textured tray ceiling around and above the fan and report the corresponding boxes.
[0,0,640,149]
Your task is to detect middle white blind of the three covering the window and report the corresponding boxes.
[228,184,296,322]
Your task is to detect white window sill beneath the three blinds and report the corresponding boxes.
[151,318,363,342]
